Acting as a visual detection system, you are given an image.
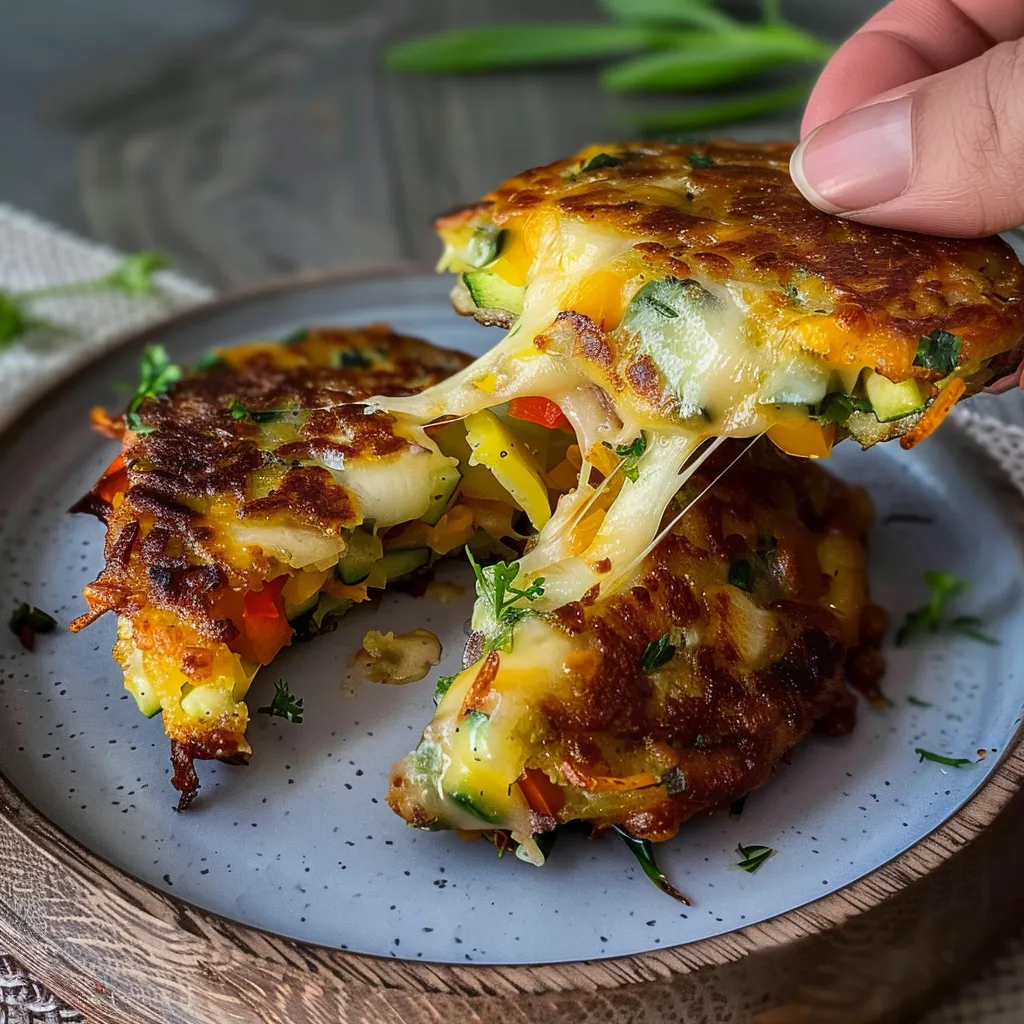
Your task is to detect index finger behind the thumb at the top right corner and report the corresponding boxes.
[802,0,1024,135]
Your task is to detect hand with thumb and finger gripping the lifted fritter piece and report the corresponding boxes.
[792,0,1024,238]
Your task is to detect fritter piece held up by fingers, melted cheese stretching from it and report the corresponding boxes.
[380,142,1024,456]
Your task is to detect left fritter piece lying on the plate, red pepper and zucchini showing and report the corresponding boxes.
[73,327,570,807]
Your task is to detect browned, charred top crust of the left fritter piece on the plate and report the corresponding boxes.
[75,325,469,641]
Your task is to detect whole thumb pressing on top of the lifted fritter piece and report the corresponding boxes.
[791,40,1024,238]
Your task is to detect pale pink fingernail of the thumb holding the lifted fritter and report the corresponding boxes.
[790,94,913,213]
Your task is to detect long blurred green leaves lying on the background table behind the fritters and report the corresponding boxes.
[385,0,833,132]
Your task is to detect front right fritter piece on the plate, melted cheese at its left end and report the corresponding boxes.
[388,441,885,863]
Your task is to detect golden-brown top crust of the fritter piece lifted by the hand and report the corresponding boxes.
[448,142,1024,386]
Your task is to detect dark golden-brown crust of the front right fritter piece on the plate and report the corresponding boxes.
[389,442,885,841]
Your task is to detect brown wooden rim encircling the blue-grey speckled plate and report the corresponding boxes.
[0,261,1024,1024]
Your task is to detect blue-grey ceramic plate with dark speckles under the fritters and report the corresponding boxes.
[0,266,1024,964]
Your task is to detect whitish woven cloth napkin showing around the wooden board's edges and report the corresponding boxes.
[0,204,1024,1024]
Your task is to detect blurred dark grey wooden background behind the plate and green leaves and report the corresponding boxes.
[0,0,882,286]
